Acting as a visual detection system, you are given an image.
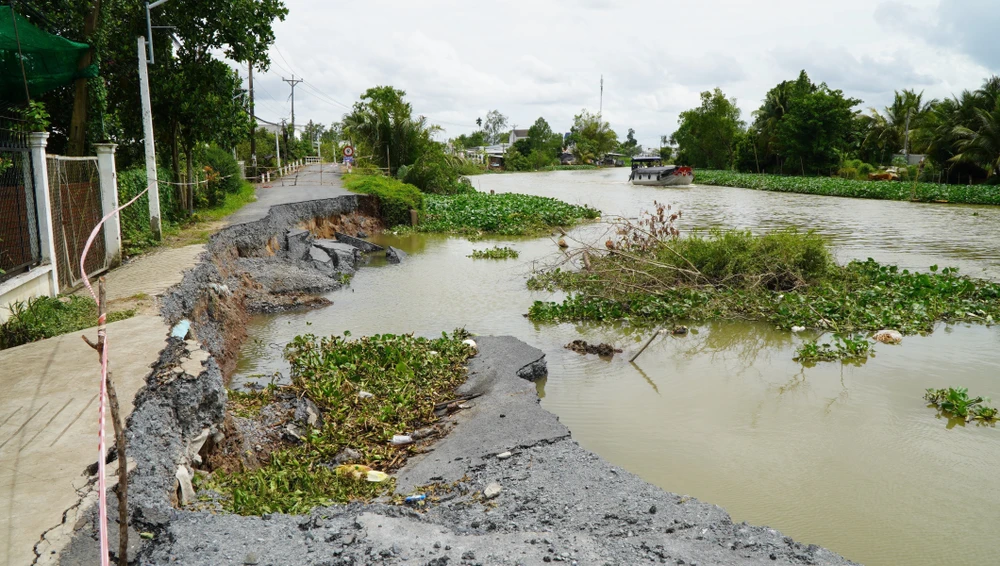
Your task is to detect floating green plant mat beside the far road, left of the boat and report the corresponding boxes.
[417,192,600,236]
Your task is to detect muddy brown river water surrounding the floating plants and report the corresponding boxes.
[234,169,1000,565]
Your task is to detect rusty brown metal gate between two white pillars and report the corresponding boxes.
[48,155,108,289]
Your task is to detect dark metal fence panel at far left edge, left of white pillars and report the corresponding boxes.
[0,129,42,281]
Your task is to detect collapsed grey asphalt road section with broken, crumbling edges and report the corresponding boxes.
[50,196,850,566]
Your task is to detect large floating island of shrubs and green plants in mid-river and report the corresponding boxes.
[528,231,1000,340]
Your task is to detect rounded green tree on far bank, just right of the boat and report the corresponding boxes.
[670,88,744,169]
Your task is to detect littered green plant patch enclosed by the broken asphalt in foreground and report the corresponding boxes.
[209,331,473,515]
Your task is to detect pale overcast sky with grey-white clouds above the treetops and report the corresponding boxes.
[241,0,1000,147]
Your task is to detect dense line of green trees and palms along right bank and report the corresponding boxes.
[669,71,1000,183]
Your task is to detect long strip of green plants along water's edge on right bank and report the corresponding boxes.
[695,169,1000,205]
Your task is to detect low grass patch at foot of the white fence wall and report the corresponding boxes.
[0,296,135,350]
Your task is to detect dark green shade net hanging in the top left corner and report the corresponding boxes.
[0,6,97,102]
